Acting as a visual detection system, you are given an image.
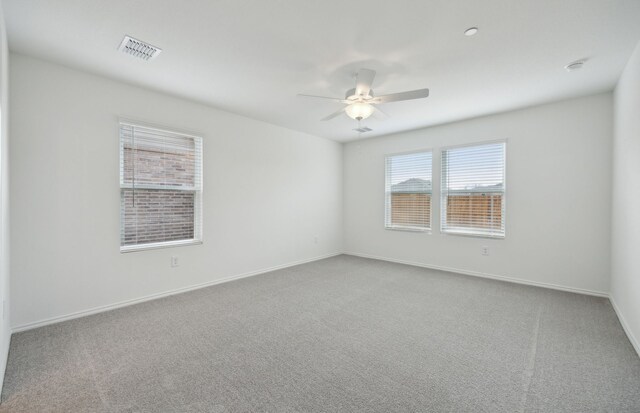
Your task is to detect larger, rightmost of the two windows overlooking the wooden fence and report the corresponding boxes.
[440,142,506,238]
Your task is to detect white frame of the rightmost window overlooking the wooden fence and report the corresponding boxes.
[440,139,508,239]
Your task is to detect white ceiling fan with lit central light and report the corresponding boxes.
[298,69,429,121]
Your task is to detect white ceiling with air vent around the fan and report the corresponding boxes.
[3,0,640,141]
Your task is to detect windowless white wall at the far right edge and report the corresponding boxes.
[611,39,640,354]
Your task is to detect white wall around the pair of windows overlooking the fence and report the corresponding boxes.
[344,93,612,294]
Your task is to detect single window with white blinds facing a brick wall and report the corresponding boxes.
[120,123,202,252]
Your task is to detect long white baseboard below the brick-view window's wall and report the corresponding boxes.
[12,252,342,333]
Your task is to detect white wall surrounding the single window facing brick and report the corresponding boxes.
[10,54,342,328]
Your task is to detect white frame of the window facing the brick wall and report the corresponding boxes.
[118,118,204,253]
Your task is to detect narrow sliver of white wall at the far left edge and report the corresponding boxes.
[0,4,11,391]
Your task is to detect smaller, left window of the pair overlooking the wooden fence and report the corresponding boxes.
[385,152,432,231]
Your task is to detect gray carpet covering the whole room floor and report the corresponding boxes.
[0,255,640,412]
